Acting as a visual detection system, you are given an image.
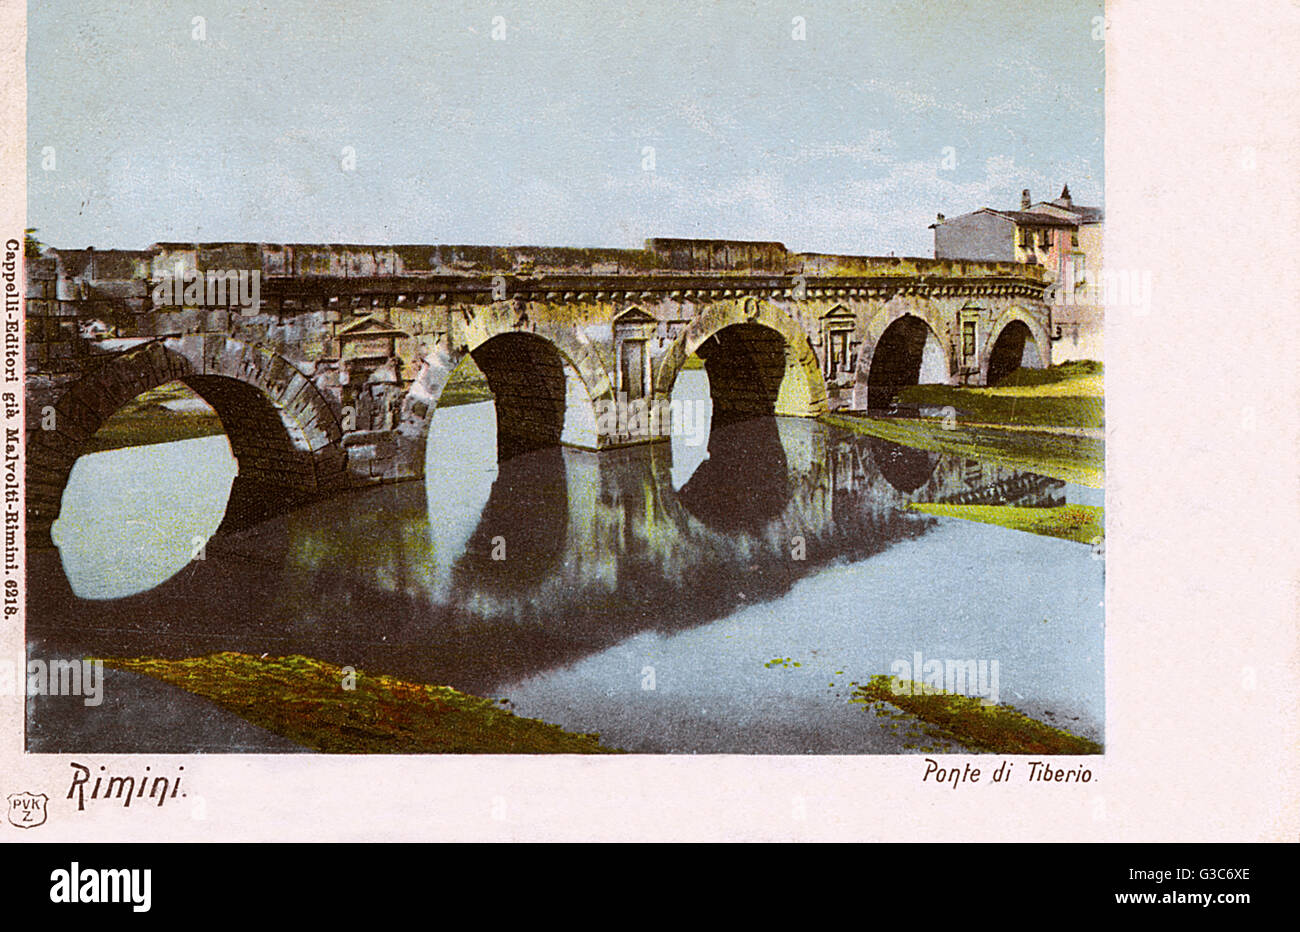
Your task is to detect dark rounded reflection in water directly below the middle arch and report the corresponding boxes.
[677,417,790,533]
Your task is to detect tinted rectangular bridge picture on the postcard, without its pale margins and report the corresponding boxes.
[20,0,1107,759]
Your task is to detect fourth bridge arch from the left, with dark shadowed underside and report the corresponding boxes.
[853,299,954,411]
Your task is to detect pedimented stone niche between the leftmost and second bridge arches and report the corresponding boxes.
[338,317,411,430]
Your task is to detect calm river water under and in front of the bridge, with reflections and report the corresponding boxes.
[29,372,1104,754]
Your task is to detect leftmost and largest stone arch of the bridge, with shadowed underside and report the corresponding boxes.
[27,334,350,546]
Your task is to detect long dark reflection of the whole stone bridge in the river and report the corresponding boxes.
[30,419,1063,692]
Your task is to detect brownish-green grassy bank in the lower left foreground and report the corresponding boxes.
[104,653,616,754]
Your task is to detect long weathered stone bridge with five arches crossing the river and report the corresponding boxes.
[26,239,1050,546]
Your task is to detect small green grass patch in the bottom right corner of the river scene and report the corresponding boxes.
[849,676,1102,754]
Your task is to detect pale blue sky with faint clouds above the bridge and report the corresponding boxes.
[27,0,1104,256]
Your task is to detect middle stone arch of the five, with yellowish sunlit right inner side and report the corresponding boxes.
[654,298,827,424]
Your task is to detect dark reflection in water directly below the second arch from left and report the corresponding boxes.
[452,446,569,593]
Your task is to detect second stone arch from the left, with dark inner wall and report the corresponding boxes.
[398,302,614,462]
